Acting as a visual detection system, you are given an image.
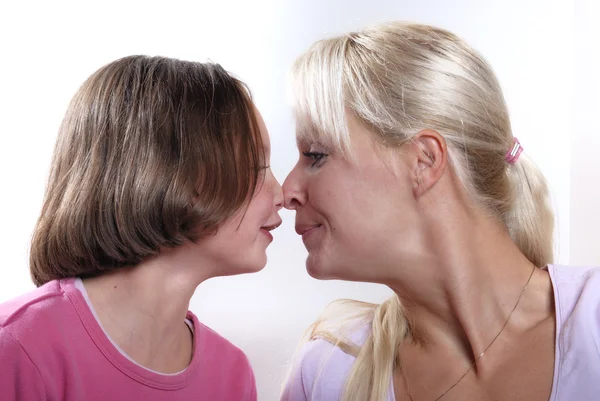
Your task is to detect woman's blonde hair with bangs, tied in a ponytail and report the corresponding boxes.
[291,22,554,401]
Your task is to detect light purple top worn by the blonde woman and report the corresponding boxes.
[281,265,600,401]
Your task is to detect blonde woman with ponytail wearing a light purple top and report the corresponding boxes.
[282,22,600,401]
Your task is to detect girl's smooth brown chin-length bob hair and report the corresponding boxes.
[30,56,265,286]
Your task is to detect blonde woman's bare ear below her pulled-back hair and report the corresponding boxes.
[409,129,448,198]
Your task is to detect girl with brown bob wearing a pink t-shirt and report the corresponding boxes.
[0,56,283,401]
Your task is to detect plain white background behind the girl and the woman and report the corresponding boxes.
[0,0,600,401]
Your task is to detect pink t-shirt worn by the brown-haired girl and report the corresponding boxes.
[0,279,256,401]
